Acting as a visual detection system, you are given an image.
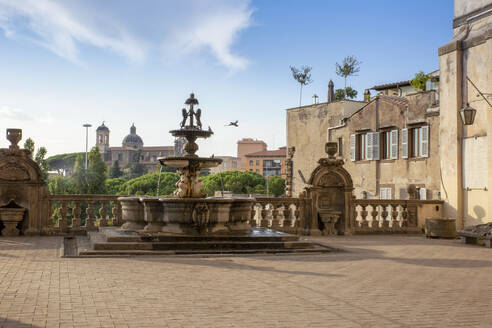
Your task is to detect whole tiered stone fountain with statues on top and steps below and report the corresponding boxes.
[78,93,327,255]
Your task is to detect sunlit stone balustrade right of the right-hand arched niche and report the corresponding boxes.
[350,199,443,233]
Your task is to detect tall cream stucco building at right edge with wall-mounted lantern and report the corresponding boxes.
[439,0,492,228]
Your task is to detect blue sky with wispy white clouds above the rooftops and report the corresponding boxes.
[0,0,453,156]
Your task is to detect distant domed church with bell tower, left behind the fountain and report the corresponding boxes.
[96,122,184,170]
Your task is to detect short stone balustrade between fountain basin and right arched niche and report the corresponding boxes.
[250,197,306,233]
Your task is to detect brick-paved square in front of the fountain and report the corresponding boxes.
[0,236,492,327]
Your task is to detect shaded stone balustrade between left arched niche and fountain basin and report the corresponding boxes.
[47,195,122,234]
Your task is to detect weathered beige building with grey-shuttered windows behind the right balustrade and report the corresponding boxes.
[287,90,440,199]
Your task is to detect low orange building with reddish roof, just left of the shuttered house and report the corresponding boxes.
[245,147,287,179]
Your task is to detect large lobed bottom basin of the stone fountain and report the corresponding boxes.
[118,197,255,235]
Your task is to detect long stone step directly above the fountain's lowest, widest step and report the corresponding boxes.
[92,240,314,251]
